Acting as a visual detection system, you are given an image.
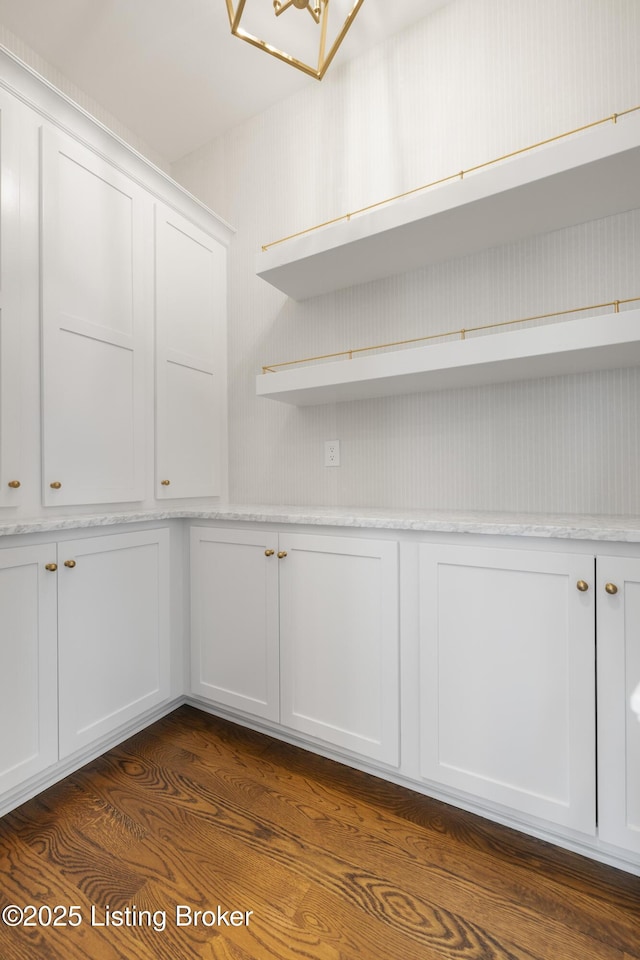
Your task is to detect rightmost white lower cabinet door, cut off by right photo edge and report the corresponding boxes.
[597,557,640,853]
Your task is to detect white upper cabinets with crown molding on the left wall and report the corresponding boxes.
[0,50,233,516]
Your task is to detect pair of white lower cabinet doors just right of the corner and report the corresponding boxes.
[191,527,399,765]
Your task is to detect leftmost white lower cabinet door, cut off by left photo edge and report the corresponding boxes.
[0,546,58,793]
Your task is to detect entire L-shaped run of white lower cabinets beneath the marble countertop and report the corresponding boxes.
[0,523,640,871]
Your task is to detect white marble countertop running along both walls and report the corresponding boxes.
[0,504,640,543]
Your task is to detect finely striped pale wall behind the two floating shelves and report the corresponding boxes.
[173,0,640,514]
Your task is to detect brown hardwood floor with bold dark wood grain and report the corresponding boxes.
[0,707,640,960]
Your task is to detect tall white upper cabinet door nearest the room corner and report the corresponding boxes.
[155,204,227,500]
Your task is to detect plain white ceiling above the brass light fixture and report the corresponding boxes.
[0,0,446,162]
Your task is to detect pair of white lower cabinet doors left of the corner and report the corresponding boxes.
[0,529,170,794]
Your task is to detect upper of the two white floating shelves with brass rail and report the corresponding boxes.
[256,111,640,300]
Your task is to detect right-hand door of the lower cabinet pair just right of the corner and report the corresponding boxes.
[279,533,399,765]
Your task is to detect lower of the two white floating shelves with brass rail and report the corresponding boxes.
[256,309,640,406]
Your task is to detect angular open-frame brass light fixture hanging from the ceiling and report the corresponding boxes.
[227,0,364,80]
